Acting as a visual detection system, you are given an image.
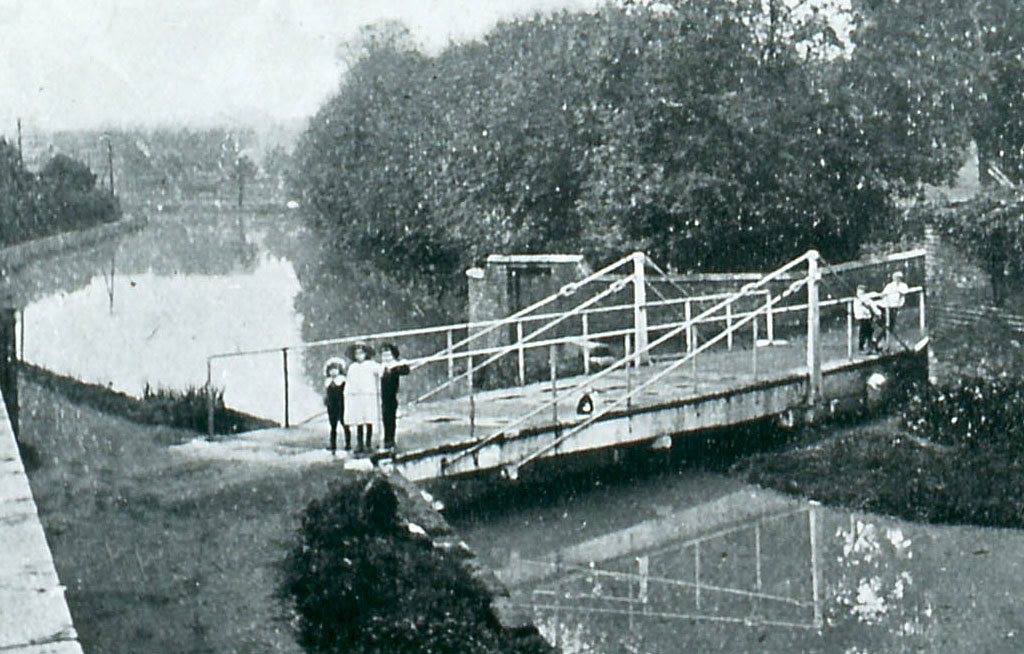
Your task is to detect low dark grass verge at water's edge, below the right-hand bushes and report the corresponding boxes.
[731,418,1024,528]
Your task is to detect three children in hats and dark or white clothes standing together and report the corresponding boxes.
[324,342,409,454]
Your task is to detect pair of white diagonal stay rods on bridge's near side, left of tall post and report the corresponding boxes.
[445,251,817,466]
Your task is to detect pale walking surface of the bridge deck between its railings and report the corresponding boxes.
[174,328,916,474]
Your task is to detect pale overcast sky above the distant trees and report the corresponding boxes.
[0,0,599,135]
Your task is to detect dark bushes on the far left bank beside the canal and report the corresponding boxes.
[0,139,120,245]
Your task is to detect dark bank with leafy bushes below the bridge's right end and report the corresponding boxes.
[731,375,1024,528]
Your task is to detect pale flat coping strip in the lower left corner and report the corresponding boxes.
[0,390,82,654]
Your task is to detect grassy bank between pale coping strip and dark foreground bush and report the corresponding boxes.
[20,377,338,654]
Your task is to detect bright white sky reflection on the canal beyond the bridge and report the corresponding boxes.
[24,254,318,420]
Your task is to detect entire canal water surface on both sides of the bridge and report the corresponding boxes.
[4,202,1024,654]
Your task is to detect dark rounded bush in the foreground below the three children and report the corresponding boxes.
[280,477,551,654]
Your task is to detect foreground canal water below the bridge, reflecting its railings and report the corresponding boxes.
[441,452,1024,654]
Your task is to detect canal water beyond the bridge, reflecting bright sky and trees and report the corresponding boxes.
[4,207,448,424]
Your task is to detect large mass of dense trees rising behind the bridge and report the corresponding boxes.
[292,0,1024,294]
